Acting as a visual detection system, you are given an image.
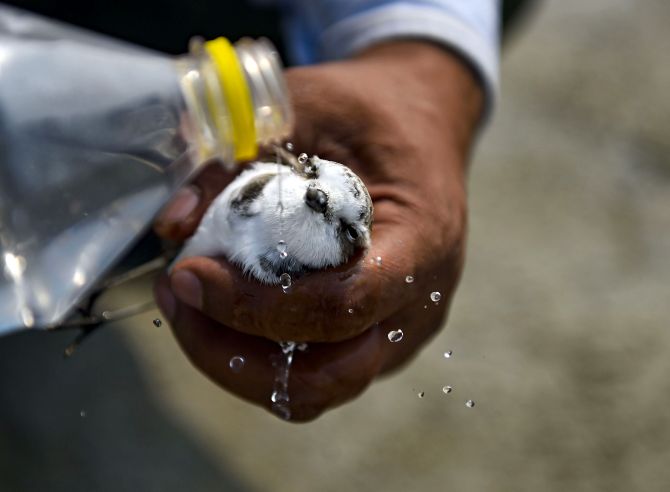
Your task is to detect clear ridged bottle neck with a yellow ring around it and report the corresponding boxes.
[177,38,293,164]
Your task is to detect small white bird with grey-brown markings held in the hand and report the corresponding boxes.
[176,148,373,284]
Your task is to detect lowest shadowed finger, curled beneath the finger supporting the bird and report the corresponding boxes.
[156,277,383,421]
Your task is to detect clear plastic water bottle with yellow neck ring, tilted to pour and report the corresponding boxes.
[0,6,292,334]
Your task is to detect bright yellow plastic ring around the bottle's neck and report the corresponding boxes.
[205,38,258,161]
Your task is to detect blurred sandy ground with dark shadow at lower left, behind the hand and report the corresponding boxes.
[0,0,670,492]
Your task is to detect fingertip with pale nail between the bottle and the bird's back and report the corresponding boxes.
[154,162,236,242]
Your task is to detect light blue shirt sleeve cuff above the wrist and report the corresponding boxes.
[282,0,500,107]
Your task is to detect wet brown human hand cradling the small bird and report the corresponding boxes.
[156,41,482,421]
